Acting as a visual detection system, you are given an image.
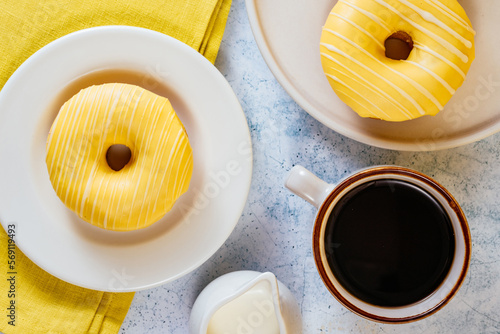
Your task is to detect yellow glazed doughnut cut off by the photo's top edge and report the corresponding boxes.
[320,0,475,121]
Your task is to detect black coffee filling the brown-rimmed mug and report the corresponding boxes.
[325,180,455,306]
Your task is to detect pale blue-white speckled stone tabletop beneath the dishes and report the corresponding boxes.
[120,0,500,334]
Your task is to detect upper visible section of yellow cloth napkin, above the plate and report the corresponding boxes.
[0,0,231,88]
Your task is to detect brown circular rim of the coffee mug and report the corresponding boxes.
[313,166,471,323]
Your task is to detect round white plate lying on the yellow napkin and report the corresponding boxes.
[0,26,252,291]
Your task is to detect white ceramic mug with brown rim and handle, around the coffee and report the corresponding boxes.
[285,166,471,323]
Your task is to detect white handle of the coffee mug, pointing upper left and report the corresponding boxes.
[285,165,335,209]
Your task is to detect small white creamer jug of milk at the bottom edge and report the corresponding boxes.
[189,270,302,334]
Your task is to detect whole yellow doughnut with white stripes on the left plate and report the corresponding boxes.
[46,84,193,231]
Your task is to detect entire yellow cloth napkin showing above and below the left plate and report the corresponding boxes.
[0,0,231,334]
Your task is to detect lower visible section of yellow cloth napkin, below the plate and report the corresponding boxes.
[0,228,134,334]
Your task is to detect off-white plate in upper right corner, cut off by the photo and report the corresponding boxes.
[246,0,500,151]
